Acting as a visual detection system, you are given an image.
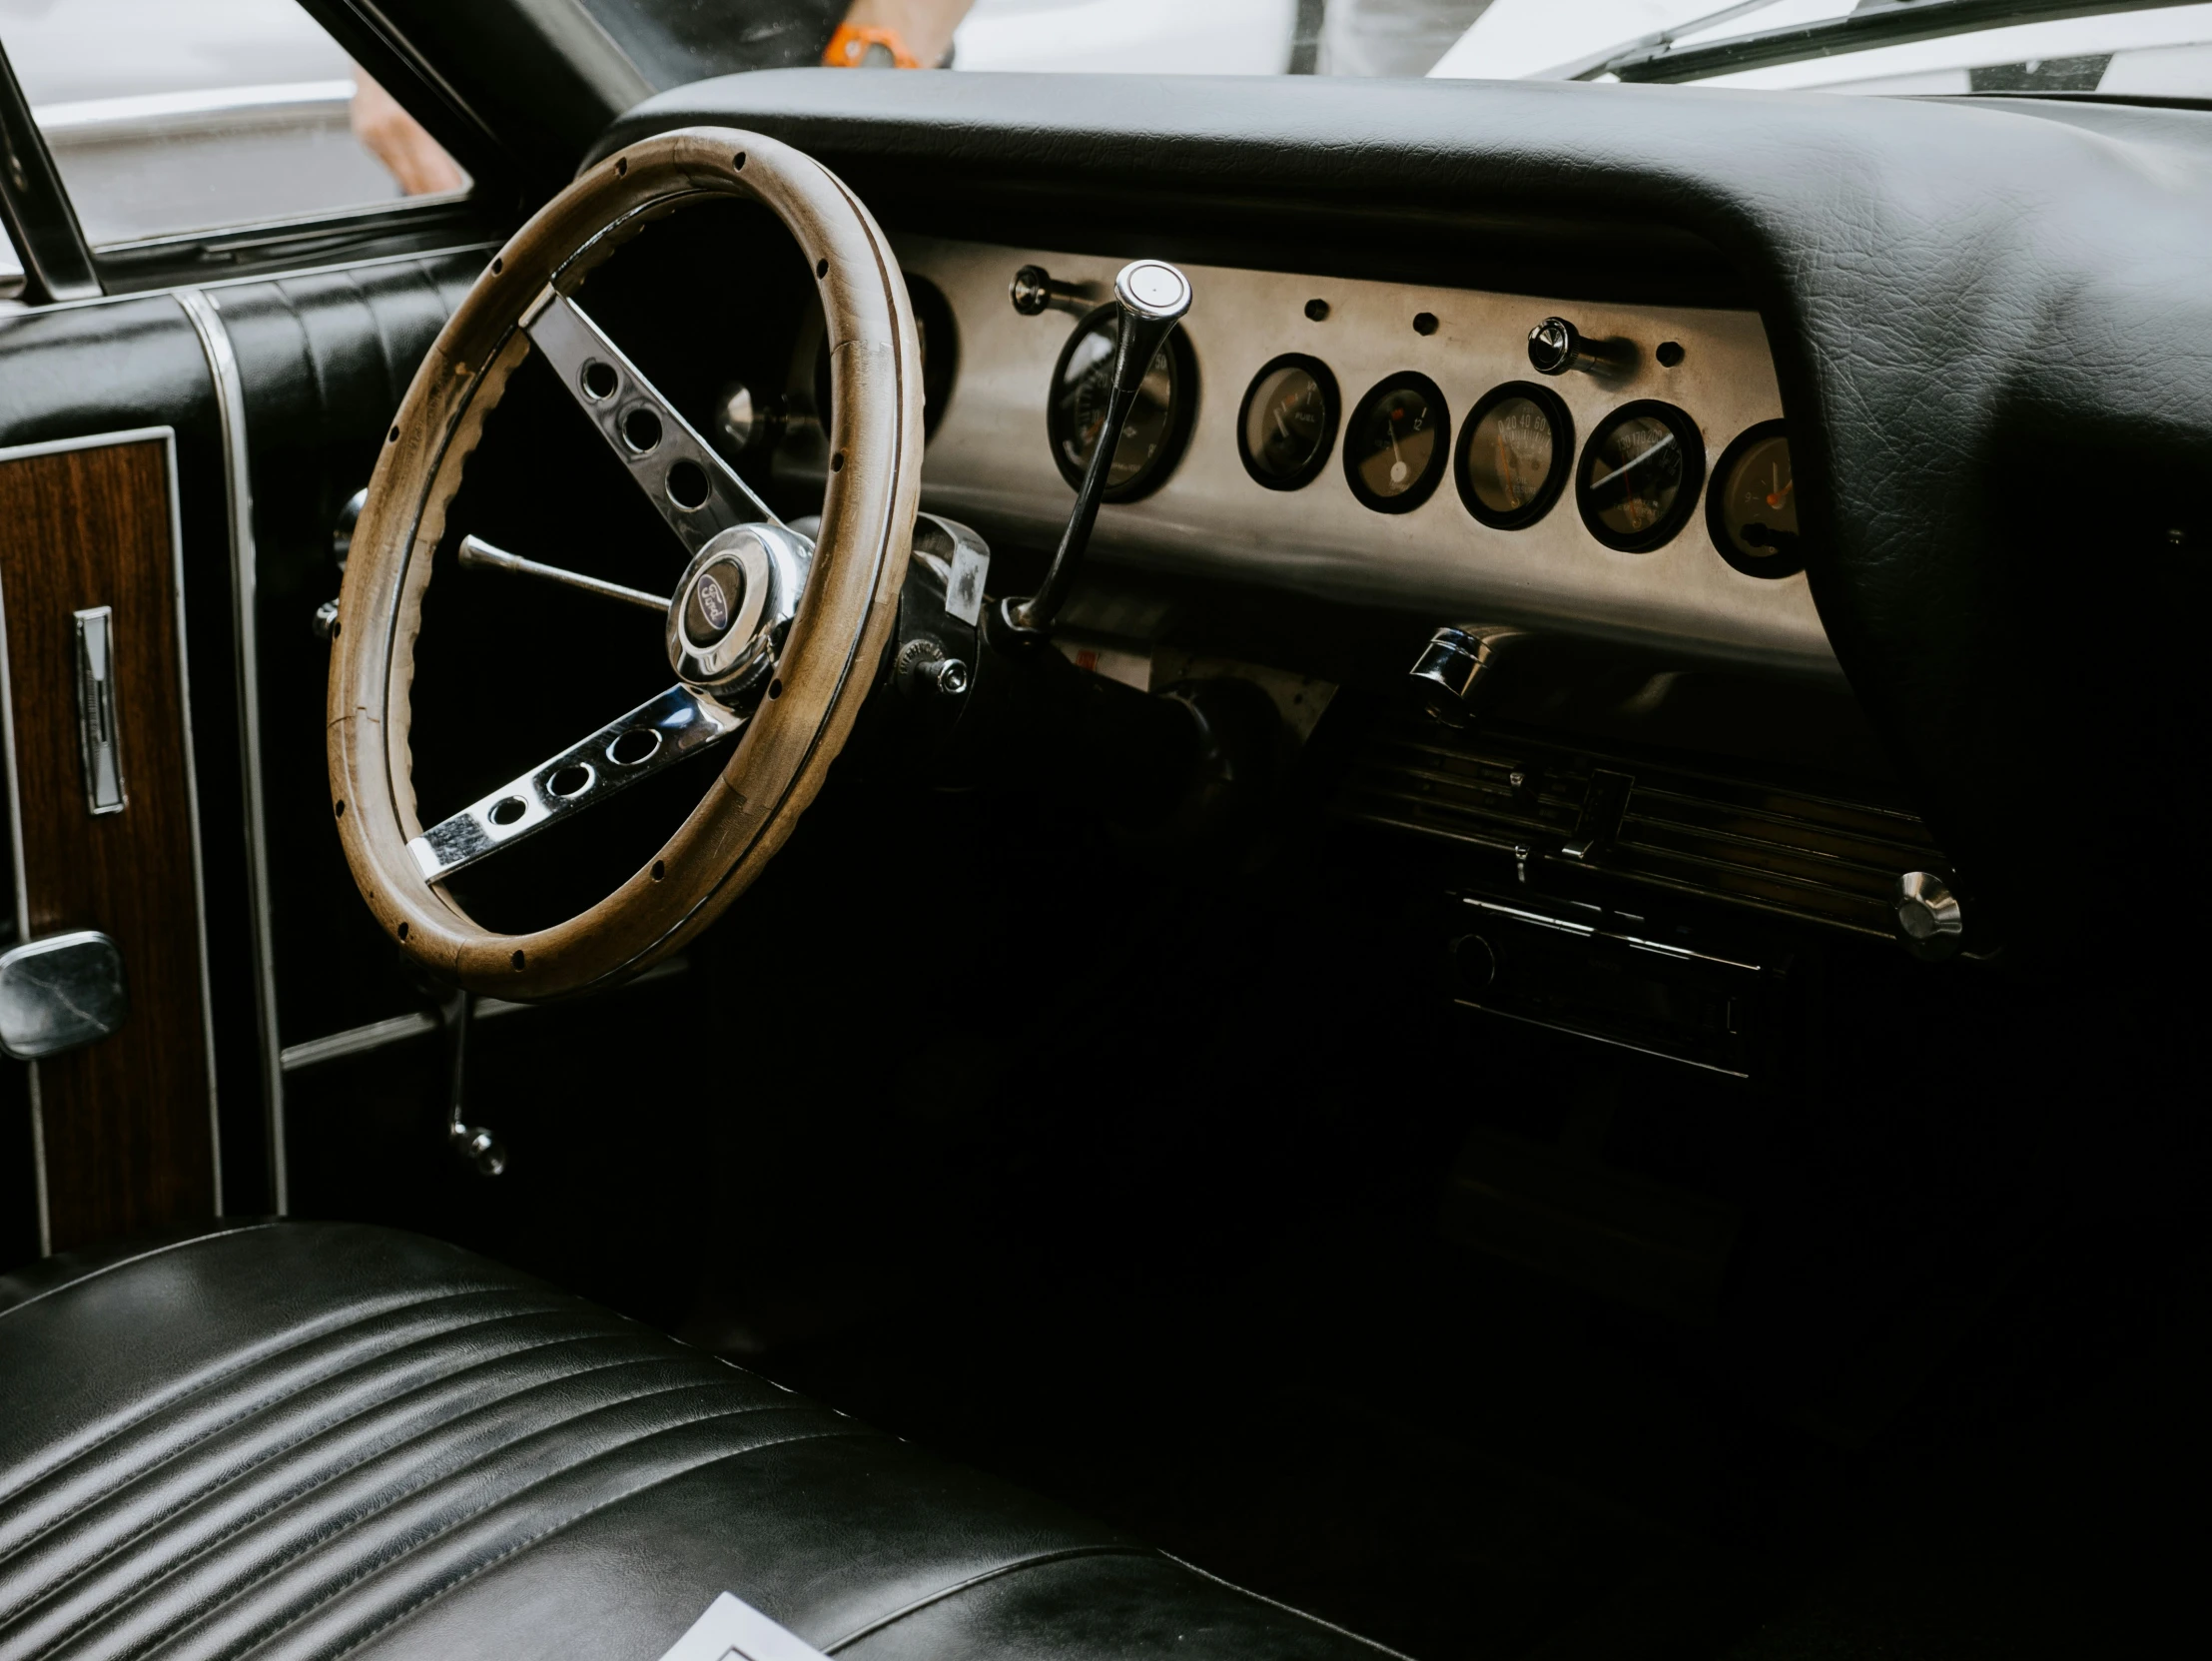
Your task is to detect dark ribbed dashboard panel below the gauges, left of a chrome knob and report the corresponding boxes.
[1336,716,1951,940]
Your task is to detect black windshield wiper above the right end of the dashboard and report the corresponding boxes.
[1583,0,2201,82]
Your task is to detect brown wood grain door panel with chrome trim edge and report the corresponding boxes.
[0,429,219,1249]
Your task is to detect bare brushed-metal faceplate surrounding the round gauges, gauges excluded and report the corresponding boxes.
[894,237,1841,677]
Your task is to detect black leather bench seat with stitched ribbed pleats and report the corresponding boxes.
[0,1224,1385,1661]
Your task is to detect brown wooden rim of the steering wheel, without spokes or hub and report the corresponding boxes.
[330,126,923,998]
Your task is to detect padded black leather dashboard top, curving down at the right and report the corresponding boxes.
[597,71,2212,962]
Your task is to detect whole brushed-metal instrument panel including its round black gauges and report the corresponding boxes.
[783,235,1839,677]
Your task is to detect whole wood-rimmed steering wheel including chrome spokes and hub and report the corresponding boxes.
[330,128,923,998]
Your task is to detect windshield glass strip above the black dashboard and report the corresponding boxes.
[586,0,2212,100]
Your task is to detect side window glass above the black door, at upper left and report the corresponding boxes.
[0,0,469,248]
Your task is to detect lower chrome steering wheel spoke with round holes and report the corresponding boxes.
[407,685,745,883]
